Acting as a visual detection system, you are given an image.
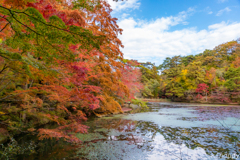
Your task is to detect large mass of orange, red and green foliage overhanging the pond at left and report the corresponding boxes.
[0,0,142,142]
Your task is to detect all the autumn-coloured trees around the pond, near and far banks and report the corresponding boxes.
[0,0,240,151]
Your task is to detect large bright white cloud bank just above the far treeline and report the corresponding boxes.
[119,9,240,64]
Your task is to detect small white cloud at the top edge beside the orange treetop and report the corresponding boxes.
[107,0,141,12]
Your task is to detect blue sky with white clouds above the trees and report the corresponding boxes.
[108,0,240,65]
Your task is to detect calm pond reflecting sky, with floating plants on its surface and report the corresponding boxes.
[12,103,240,160]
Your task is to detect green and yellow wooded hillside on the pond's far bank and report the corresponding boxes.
[141,40,240,103]
